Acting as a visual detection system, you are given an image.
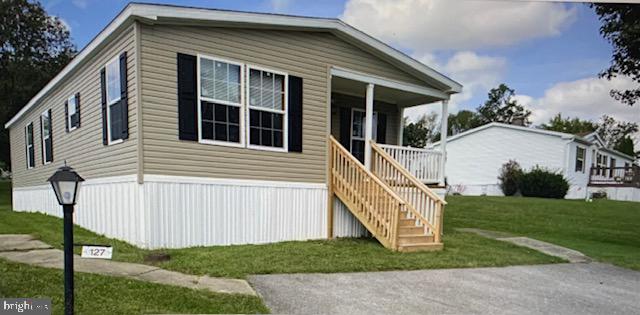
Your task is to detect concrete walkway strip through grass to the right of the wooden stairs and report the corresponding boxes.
[456,228,591,263]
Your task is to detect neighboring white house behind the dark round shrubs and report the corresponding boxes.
[434,123,640,201]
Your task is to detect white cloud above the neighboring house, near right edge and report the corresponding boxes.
[517,77,640,124]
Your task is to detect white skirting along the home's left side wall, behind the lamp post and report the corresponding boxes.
[13,176,144,246]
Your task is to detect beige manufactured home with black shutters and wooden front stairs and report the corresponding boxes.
[5,4,462,251]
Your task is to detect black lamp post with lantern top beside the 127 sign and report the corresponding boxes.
[48,162,84,315]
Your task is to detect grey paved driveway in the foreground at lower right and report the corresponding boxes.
[249,263,640,314]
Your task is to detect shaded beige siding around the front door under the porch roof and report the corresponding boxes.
[331,93,400,149]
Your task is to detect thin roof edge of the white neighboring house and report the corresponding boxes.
[432,122,635,161]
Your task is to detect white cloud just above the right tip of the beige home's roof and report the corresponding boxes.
[405,51,507,121]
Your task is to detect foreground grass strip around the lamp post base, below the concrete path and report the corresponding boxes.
[0,259,269,314]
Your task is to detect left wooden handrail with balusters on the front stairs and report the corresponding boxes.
[329,136,406,250]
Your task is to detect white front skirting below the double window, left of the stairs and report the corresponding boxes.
[144,176,327,248]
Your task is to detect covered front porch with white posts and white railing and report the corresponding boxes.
[330,69,449,188]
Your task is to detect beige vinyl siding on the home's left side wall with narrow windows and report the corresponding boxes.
[10,25,138,187]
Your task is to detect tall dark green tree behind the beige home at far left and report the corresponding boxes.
[0,0,76,170]
